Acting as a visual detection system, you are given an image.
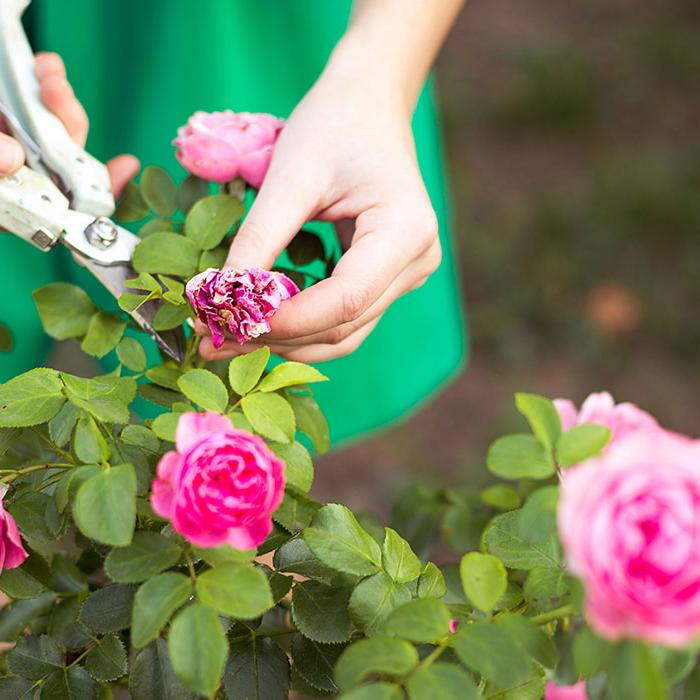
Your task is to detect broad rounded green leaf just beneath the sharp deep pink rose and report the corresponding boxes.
[197,563,274,620]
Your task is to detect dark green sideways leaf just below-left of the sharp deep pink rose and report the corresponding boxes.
[104,531,181,583]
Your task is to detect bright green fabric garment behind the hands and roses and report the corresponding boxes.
[0,0,465,442]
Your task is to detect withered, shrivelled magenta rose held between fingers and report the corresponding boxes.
[186,267,299,348]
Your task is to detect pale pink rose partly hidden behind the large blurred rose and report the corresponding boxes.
[554,391,661,447]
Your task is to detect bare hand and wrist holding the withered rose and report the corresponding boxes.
[197,0,462,362]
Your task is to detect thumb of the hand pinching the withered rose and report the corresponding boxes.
[226,167,315,270]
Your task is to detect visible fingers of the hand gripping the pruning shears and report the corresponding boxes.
[0,53,139,197]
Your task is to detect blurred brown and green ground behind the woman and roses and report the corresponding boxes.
[314,0,700,515]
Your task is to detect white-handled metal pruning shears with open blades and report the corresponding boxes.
[0,0,185,361]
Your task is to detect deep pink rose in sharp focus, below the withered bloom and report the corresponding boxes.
[151,413,284,549]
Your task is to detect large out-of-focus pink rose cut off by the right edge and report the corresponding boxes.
[558,430,700,646]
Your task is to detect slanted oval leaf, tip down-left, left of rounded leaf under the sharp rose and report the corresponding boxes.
[131,571,192,649]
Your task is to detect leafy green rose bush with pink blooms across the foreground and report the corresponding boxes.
[0,117,700,700]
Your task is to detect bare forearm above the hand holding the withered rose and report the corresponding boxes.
[328,0,464,112]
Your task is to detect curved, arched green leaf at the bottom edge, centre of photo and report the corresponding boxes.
[335,637,418,691]
